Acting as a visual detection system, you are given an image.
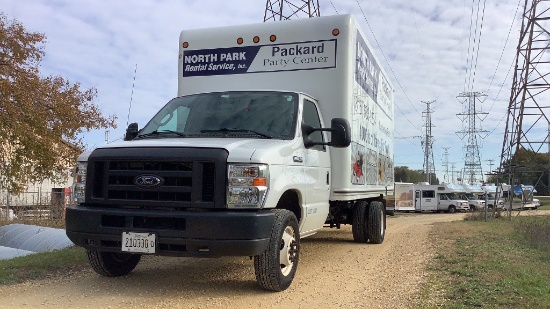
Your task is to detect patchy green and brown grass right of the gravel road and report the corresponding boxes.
[418,216,550,308]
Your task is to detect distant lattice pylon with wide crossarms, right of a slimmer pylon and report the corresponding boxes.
[456,92,488,185]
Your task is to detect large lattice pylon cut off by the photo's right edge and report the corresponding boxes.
[500,0,550,175]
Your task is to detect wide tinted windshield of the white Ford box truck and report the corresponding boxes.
[137,91,298,139]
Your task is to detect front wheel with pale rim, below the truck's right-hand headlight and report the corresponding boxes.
[254,209,300,292]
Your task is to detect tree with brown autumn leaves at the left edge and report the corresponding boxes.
[0,13,116,193]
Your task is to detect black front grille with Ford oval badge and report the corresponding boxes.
[86,148,227,208]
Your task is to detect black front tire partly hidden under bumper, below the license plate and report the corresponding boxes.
[87,250,141,277]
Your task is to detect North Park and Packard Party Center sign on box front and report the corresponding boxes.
[180,39,336,77]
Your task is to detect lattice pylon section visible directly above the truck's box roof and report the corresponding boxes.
[264,0,321,22]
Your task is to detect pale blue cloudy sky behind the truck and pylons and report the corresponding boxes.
[0,0,536,181]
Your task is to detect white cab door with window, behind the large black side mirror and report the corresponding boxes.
[300,98,330,234]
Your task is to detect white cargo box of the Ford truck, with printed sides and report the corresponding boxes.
[178,15,394,200]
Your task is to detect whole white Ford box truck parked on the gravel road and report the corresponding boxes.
[66,15,394,291]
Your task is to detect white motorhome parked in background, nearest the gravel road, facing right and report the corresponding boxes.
[414,184,470,213]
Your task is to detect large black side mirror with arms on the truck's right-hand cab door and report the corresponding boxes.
[302,118,351,148]
